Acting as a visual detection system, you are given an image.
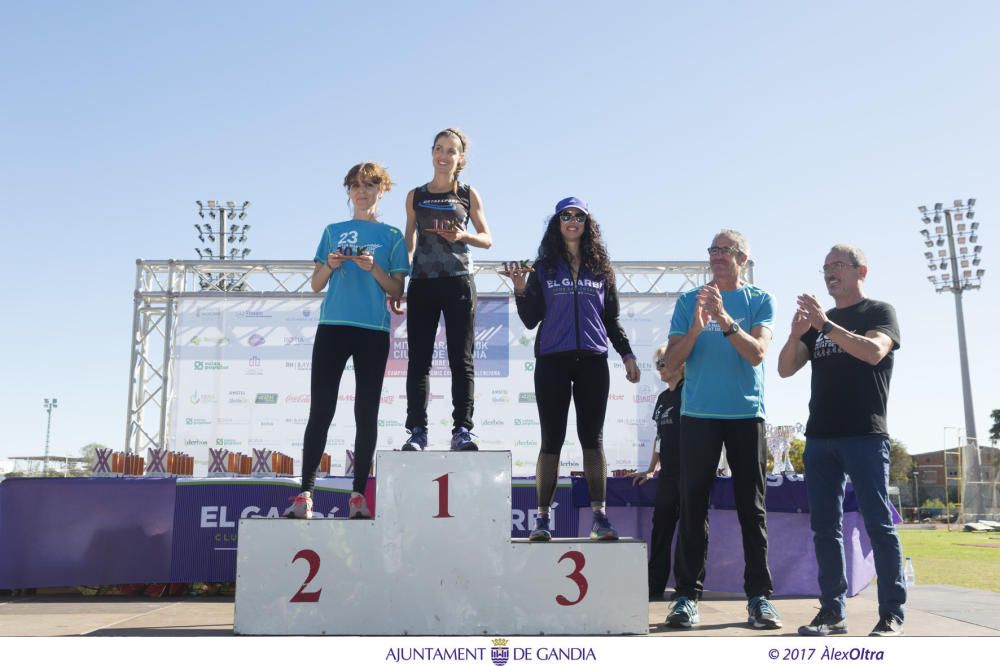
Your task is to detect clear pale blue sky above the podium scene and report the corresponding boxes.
[0,1,1000,458]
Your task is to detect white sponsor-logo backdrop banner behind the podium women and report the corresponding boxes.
[170,294,676,476]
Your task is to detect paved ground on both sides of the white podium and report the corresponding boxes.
[0,585,1000,637]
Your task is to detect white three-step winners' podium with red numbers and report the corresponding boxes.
[234,451,649,636]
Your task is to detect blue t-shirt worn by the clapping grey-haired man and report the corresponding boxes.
[670,284,774,419]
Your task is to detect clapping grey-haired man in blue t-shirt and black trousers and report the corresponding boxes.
[666,229,781,629]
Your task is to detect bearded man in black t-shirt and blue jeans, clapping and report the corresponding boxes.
[778,245,906,636]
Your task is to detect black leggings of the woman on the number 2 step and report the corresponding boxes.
[302,324,389,493]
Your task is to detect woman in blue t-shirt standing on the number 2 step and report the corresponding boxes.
[284,162,410,518]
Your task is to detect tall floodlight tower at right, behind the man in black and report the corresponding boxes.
[917,199,985,516]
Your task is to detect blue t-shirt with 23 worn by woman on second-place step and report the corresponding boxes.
[314,220,410,331]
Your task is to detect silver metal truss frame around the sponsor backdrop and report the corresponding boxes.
[125,259,753,453]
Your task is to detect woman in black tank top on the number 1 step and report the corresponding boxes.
[403,128,493,451]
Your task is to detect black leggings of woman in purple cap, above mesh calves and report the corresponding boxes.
[535,355,611,455]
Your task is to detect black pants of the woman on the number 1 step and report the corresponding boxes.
[406,275,476,430]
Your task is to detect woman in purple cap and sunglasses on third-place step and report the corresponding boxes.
[504,197,639,541]
